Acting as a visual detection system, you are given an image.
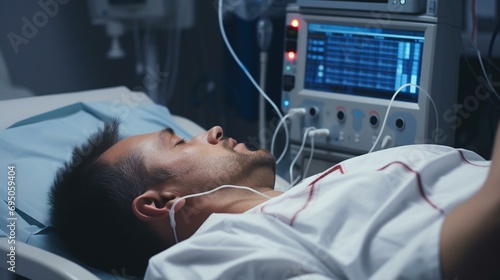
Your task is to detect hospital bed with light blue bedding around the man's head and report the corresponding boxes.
[0,87,205,279]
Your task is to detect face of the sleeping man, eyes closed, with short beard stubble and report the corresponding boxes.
[102,126,275,194]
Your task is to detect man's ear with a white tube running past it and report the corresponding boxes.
[132,190,185,221]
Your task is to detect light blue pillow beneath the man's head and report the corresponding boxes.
[0,102,192,274]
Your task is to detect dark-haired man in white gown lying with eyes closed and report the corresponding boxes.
[0,86,500,279]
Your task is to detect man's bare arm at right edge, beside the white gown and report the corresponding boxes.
[440,125,500,280]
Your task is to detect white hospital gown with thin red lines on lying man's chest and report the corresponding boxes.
[145,145,489,280]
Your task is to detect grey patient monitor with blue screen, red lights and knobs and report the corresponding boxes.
[281,0,462,172]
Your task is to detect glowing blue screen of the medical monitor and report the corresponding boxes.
[304,23,425,102]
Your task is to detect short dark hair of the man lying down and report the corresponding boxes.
[50,120,167,275]
